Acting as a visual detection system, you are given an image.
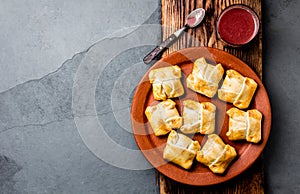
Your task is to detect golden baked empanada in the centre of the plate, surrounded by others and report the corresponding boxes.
[180,100,216,134]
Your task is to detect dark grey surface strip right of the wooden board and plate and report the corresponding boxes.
[263,0,300,193]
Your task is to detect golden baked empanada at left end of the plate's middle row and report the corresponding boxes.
[145,99,182,136]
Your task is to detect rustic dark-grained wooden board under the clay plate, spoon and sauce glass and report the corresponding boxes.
[157,0,264,194]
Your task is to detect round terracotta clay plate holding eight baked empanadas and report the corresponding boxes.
[131,47,271,186]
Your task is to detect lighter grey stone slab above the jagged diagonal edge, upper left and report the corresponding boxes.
[0,0,157,92]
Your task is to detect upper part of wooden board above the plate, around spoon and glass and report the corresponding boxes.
[162,0,262,76]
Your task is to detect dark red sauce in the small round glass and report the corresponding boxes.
[218,8,255,45]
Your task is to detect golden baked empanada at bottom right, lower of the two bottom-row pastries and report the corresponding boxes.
[196,134,237,174]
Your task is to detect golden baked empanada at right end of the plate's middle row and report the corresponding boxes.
[226,108,262,143]
